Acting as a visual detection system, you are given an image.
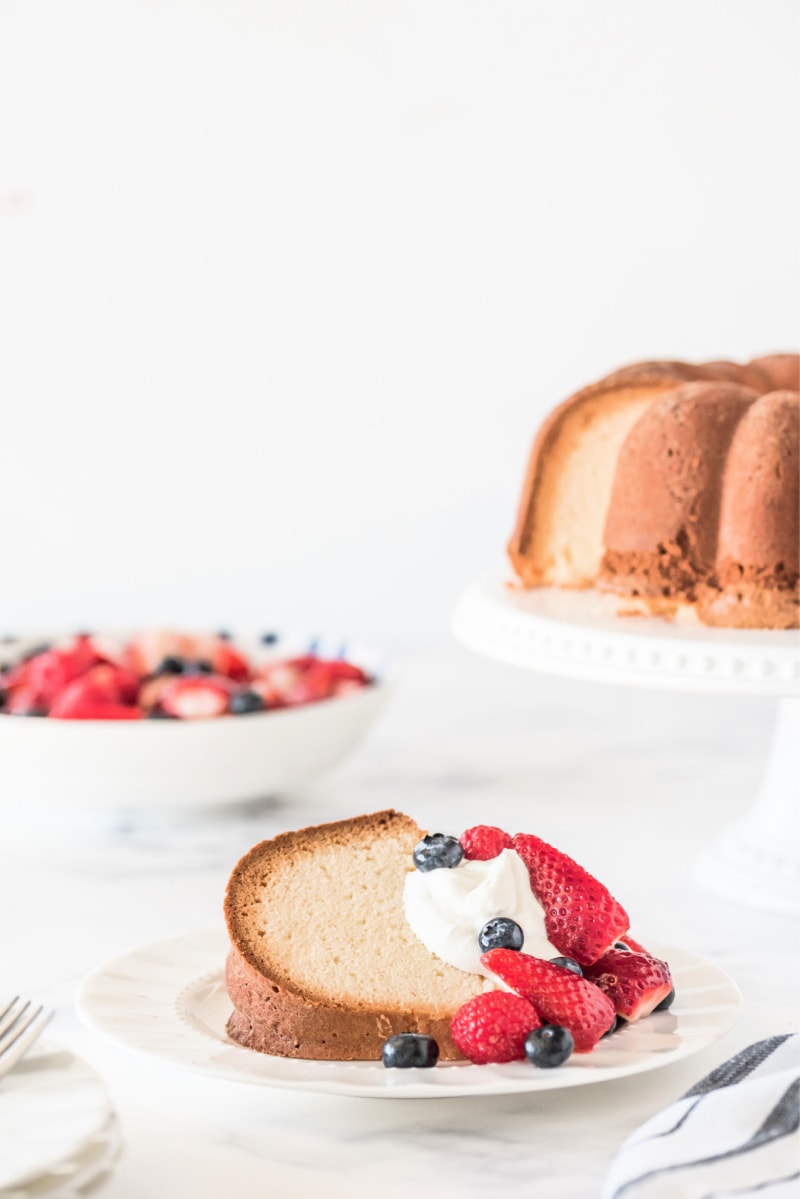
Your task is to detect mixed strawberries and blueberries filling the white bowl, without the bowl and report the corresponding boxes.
[0,629,375,721]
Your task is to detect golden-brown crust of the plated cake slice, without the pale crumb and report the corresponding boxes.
[224,811,483,1061]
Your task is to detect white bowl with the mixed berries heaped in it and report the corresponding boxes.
[0,629,386,809]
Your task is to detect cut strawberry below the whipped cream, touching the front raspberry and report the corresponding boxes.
[481,950,615,1053]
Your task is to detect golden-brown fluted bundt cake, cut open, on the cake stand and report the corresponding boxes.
[509,354,800,628]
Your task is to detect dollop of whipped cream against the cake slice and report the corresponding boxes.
[403,849,559,977]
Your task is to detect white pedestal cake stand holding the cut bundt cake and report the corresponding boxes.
[452,578,800,914]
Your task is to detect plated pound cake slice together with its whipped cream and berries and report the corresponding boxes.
[224,812,673,1067]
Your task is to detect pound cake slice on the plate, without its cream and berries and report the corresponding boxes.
[224,811,487,1061]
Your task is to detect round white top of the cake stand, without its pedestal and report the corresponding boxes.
[452,578,800,695]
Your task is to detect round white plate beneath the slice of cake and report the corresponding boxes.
[78,928,740,1098]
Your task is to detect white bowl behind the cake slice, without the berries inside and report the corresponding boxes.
[0,633,387,815]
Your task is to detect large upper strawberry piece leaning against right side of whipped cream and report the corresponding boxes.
[513,833,628,965]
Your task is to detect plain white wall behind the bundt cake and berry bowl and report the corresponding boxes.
[0,0,800,645]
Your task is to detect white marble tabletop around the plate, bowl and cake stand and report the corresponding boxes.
[0,644,798,1199]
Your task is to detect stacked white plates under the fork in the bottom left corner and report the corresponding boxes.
[0,1041,121,1199]
